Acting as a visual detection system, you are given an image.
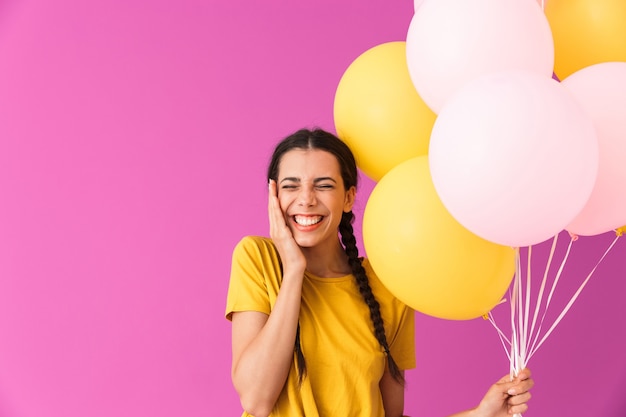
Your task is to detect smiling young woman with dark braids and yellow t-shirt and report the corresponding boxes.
[226,129,533,417]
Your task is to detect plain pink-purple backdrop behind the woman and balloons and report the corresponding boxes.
[0,0,626,417]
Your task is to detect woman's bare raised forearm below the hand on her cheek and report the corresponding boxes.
[232,273,302,415]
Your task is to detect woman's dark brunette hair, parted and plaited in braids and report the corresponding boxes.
[267,129,404,384]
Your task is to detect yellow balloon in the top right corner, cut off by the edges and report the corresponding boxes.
[545,0,626,80]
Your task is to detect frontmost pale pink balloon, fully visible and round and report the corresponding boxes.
[429,71,598,247]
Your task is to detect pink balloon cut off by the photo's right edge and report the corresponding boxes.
[562,62,626,236]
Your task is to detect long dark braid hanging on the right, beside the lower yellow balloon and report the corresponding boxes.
[339,211,404,385]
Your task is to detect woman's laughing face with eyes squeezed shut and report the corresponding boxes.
[277,149,356,247]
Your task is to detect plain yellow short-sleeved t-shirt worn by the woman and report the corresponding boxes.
[226,236,415,417]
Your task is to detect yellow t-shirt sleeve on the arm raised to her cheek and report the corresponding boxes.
[225,236,278,320]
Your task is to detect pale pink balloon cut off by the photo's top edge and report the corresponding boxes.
[406,0,554,113]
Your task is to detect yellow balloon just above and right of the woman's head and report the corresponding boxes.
[334,42,436,181]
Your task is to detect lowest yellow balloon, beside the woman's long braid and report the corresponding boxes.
[363,156,516,320]
